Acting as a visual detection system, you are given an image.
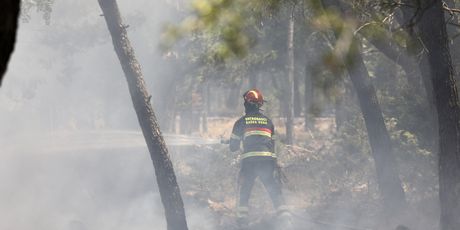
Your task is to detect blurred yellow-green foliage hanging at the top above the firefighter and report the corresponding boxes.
[164,0,279,59]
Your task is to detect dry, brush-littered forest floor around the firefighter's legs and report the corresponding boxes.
[173,118,437,230]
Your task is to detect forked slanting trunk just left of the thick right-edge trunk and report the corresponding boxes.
[342,0,438,150]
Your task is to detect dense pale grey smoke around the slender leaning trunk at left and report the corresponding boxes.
[0,0,217,230]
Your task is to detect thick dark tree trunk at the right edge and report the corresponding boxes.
[419,0,460,230]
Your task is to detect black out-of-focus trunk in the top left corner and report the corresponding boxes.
[0,0,21,85]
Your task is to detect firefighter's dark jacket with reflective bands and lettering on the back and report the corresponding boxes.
[230,111,276,159]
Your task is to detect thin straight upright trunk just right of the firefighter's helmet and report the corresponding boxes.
[286,5,295,145]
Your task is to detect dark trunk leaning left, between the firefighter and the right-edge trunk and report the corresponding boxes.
[323,0,406,219]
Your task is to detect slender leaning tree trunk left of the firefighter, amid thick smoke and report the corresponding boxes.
[99,0,187,230]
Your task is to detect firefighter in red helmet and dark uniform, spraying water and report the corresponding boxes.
[230,89,286,223]
